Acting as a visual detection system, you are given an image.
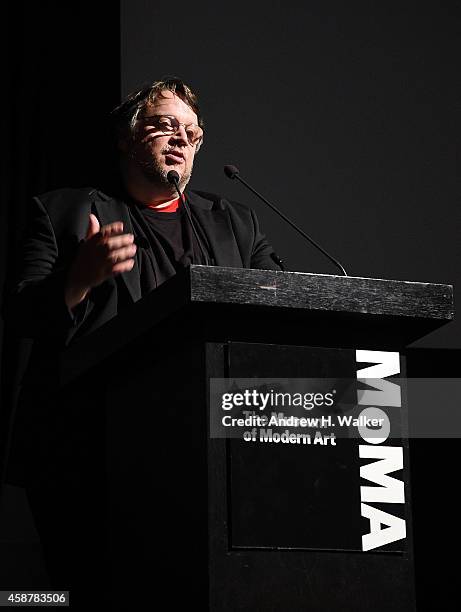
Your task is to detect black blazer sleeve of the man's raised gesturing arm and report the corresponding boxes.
[4,198,89,343]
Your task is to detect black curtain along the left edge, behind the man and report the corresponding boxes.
[0,0,120,588]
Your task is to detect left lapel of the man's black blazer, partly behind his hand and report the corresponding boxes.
[93,191,141,302]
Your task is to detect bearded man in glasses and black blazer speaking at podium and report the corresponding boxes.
[9,78,280,362]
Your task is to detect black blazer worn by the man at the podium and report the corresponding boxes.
[6,188,280,346]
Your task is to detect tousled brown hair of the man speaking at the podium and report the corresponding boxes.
[111,76,204,138]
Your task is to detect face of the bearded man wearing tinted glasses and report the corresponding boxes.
[128,90,198,189]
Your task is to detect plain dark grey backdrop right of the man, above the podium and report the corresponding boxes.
[121,0,461,348]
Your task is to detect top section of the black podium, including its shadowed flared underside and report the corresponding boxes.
[61,265,454,383]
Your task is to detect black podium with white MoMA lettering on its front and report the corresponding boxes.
[56,266,453,612]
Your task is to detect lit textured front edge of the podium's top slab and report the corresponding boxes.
[184,266,454,321]
